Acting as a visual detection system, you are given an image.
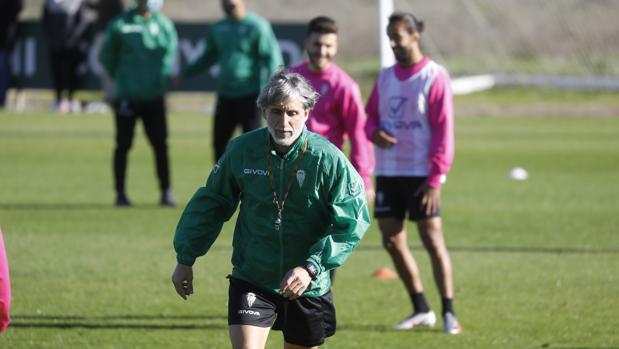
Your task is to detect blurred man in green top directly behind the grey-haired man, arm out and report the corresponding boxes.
[173,0,284,159]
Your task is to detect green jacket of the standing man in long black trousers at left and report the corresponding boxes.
[99,9,178,101]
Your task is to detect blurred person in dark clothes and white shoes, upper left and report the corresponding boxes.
[43,0,88,113]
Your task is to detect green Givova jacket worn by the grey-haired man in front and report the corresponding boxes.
[174,128,370,297]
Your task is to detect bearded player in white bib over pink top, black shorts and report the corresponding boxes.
[366,13,462,334]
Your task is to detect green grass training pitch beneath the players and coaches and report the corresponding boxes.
[0,104,619,349]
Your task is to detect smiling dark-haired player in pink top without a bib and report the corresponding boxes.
[290,16,374,201]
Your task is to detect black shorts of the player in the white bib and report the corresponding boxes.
[374,176,441,221]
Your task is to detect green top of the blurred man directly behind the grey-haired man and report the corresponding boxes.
[181,13,284,98]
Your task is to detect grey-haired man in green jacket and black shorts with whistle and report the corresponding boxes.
[172,71,370,348]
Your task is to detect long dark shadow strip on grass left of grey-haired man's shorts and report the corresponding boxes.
[10,315,228,330]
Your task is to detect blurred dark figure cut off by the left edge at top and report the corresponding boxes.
[0,0,23,109]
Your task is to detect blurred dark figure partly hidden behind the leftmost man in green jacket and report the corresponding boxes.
[87,0,123,104]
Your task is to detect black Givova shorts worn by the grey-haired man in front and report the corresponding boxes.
[228,278,335,347]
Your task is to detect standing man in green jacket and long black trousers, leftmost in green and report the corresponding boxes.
[99,0,178,206]
